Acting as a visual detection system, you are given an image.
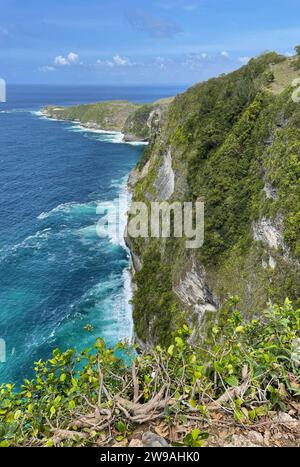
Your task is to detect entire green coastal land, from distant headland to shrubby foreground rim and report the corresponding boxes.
[0,53,300,448]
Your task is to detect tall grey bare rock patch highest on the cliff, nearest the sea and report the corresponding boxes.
[155,149,175,201]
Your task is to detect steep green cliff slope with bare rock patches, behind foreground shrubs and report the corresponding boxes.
[127,53,300,343]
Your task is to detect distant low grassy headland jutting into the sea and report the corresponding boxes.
[42,98,172,141]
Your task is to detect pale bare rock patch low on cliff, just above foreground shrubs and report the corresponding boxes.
[174,261,217,317]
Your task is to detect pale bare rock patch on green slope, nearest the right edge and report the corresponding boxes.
[253,217,284,250]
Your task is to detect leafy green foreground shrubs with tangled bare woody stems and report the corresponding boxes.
[0,297,300,447]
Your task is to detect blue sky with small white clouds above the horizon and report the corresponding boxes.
[0,0,300,85]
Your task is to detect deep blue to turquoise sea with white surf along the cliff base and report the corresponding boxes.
[0,86,181,383]
